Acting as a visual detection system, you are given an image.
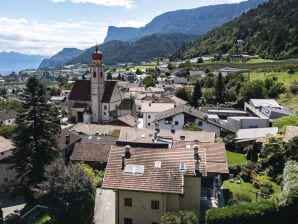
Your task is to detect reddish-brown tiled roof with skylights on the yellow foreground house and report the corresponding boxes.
[103,146,200,194]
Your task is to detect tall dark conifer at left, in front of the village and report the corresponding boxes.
[13,77,60,200]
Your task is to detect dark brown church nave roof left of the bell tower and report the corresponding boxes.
[68,80,91,101]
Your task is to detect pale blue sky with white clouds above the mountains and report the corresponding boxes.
[0,0,243,56]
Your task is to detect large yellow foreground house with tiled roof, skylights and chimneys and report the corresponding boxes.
[102,142,228,224]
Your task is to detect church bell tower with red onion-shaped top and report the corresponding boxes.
[91,46,105,123]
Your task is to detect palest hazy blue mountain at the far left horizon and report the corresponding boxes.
[0,52,45,75]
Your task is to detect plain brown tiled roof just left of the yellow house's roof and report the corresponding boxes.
[70,142,111,162]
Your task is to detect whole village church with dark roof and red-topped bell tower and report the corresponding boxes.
[68,47,122,123]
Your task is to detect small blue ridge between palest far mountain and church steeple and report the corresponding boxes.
[38,48,83,69]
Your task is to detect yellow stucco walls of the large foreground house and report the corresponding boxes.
[115,176,201,224]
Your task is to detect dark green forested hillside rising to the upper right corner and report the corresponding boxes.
[172,0,298,59]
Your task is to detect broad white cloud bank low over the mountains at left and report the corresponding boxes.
[0,17,108,56]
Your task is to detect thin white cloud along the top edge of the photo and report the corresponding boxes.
[52,0,136,9]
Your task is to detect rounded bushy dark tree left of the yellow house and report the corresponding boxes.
[34,160,96,224]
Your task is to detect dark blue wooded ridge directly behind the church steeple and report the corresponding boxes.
[66,34,197,65]
